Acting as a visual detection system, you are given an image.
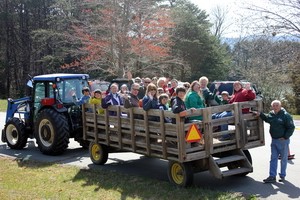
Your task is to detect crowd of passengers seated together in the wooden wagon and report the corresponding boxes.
[77,76,255,129]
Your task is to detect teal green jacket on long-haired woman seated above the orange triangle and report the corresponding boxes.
[184,91,205,120]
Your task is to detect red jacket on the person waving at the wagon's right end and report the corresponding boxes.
[229,88,256,113]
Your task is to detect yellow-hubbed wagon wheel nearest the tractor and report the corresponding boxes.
[89,142,108,165]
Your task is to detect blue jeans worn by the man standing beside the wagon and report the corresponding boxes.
[269,139,290,177]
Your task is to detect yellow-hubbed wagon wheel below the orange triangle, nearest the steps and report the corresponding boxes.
[168,161,194,187]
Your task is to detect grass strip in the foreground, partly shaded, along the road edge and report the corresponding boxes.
[0,157,256,200]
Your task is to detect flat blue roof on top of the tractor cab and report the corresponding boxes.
[33,73,89,81]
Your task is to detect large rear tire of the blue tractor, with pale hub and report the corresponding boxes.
[35,109,69,155]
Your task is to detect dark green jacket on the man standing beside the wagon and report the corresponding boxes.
[260,108,295,139]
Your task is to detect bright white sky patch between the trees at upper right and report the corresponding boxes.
[190,0,269,37]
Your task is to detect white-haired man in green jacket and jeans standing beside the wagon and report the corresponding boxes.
[254,100,295,183]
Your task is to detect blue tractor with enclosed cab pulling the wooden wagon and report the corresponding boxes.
[1,74,89,155]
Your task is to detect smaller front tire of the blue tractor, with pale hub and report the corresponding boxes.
[4,117,28,149]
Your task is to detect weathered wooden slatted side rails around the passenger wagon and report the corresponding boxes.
[82,101,264,162]
